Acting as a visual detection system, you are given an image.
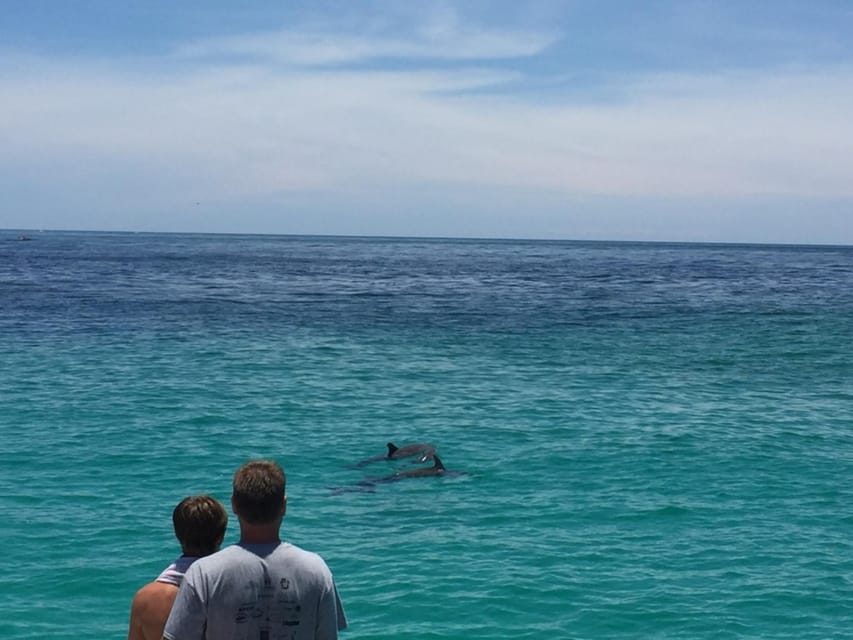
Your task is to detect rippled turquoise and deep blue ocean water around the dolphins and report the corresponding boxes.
[0,231,853,640]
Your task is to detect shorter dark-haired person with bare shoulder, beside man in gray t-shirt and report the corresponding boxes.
[127,496,228,640]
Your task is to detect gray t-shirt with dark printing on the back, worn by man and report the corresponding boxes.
[163,542,347,640]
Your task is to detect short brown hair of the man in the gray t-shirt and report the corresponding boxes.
[233,460,286,524]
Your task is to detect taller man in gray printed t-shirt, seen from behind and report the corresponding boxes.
[163,460,347,640]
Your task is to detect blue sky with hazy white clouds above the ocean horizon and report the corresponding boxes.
[0,0,853,244]
